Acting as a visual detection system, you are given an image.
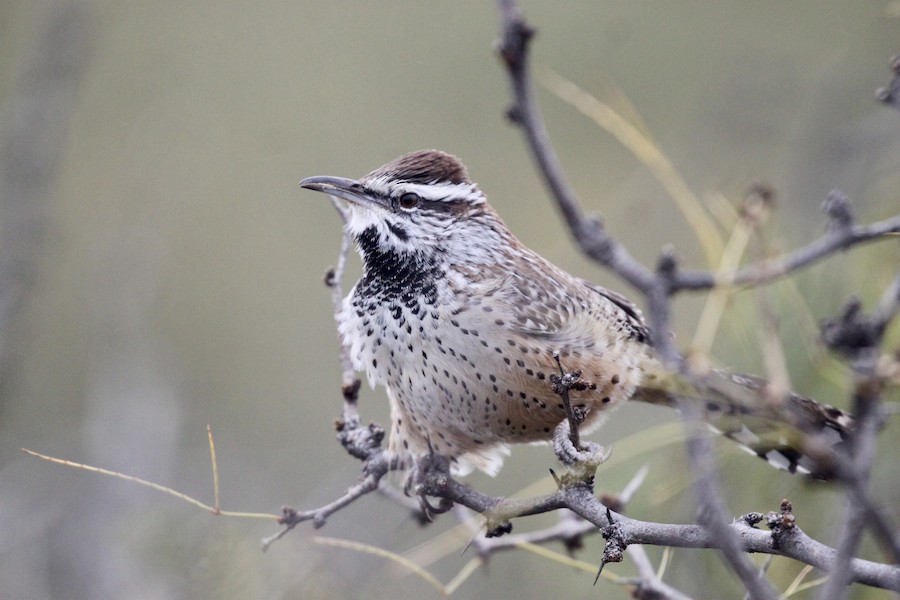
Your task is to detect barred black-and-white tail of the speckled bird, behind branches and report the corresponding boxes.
[633,358,855,479]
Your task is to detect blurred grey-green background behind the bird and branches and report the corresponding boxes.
[0,0,900,599]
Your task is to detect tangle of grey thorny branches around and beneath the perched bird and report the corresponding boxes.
[272,0,900,598]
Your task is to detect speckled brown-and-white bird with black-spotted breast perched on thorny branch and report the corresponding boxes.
[300,150,853,475]
